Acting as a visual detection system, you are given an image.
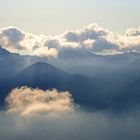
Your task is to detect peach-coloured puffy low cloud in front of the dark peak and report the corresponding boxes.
[6,86,75,116]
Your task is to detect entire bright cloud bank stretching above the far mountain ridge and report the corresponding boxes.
[0,23,140,57]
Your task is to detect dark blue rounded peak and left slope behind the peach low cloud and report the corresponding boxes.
[0,62,70,105]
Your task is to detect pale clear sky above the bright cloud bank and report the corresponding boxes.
[0,0,140,35]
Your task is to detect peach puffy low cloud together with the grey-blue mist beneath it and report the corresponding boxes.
[0,87,140,140]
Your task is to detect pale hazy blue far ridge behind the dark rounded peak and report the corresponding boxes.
[0,47,140,79]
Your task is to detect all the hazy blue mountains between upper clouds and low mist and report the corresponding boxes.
[0,48,140,111]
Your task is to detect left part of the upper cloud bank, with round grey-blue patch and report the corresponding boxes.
[0,27,58,57]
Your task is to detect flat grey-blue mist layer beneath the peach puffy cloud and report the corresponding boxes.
[0,111,140,140]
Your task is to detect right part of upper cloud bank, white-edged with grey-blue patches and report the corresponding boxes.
[61,24,140,54]
